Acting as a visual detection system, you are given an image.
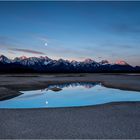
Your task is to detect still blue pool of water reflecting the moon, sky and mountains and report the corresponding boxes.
[0,82,140,108]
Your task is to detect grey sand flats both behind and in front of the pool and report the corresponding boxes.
[0,74,140,139]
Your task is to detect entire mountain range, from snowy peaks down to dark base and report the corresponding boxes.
[0,55,140,73]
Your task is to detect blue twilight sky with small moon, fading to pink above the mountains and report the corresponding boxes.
[0,1,140,66]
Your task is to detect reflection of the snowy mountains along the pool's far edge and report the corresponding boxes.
[47,82,99,89]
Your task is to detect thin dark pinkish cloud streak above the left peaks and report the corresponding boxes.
[9,48,45,54]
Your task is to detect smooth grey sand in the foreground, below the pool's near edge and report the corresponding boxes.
[0,102,140,139]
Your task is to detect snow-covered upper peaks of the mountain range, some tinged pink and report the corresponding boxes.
[0,55,132,66]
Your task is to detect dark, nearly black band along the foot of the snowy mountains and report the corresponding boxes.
[0,63,140,73]
